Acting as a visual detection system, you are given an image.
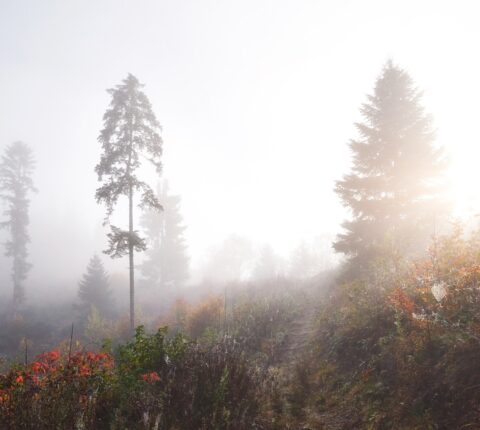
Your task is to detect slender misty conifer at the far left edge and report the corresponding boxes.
[0,142,36,311]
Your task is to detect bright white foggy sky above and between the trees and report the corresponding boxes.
[0,0,480,288]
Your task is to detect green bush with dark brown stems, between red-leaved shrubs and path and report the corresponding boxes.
[111,327,259,429]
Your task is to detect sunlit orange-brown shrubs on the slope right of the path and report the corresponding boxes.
[292,228,480,429]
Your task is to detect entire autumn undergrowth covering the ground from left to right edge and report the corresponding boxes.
[4,228,480,430]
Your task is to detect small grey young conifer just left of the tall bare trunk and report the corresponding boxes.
[78,255,112,316]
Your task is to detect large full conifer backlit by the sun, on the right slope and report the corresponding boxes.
[334,61,446,275]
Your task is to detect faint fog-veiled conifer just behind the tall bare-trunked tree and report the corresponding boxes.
[142,181,189,287]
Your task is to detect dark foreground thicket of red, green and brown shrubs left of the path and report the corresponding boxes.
[0,327,262,430]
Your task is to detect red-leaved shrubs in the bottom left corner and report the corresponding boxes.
[0,351,113,430]
